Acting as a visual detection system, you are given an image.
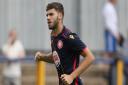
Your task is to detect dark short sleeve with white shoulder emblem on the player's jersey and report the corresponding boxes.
[67,33,87,54]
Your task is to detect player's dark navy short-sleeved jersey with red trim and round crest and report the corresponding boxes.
[51,27,87,85]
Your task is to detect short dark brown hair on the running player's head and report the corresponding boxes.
[46,2,64,16]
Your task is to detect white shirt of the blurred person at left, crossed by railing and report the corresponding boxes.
[3,40,24,77]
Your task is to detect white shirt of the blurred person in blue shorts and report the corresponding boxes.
[103,2,119,37]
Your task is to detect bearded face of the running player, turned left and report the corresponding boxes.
[46,9,58,30]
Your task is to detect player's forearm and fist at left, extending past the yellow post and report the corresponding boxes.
[35,52,54,63]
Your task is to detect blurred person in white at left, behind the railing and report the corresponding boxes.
[2,29,25,85]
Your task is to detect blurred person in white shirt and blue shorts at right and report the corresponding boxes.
[102,0,124,85]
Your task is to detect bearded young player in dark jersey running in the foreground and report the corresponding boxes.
[35,2,95,85]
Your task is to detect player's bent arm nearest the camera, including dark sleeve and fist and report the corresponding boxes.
[61,34,95,84]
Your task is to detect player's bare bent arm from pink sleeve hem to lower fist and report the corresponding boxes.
[61,48,95,85]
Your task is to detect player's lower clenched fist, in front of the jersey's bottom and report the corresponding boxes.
[60,74,74,85]
